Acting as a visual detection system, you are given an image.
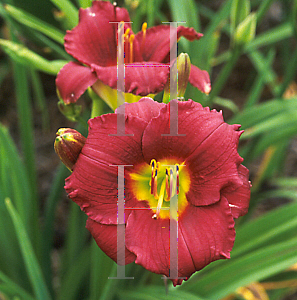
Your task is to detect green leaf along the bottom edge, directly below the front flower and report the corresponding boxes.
[118,286,203,300]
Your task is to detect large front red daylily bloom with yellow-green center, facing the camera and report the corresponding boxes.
[65,98,250,285]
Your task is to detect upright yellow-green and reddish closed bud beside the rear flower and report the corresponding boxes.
[163,53,191,103]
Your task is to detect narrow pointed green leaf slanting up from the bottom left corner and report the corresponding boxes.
[5,198,51,300]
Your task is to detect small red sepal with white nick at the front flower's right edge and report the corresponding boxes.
[221,165,251,218]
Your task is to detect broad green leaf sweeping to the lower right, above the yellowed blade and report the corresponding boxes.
[180,238,297,300]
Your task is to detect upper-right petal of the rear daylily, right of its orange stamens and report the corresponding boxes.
[135,25,203,63]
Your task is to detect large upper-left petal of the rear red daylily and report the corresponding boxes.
[65,1,131,66]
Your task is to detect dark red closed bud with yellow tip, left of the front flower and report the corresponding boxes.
[54,128,86,171]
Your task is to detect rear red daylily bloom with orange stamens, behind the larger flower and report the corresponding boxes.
[56,1,211,108]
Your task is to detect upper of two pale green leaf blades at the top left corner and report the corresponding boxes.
[4,4,64,45]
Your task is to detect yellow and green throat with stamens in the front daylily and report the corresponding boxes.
[130,159,190,219]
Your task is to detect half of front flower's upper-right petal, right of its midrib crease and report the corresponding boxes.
[185,123,243,205]
